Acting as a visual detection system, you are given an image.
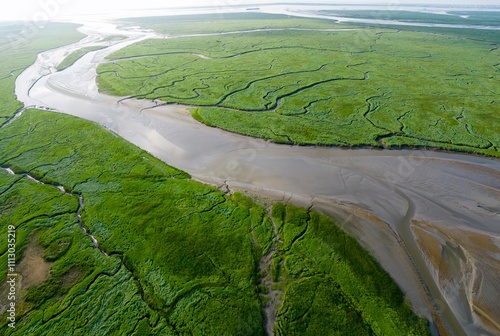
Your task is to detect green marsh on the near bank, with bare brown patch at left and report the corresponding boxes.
[0,15,428,335]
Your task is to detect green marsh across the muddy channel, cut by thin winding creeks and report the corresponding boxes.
[98,14,500,157]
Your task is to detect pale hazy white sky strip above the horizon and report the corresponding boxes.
[0,0,499,21]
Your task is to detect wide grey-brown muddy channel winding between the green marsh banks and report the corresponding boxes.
[16,23,500,335]
